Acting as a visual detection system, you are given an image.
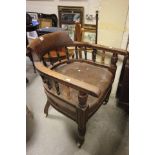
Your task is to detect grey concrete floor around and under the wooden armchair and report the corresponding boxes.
[26,60,129,155]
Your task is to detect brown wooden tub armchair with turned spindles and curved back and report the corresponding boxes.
[28,32,128,147]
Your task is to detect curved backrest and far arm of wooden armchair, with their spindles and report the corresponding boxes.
[28,32,128,77]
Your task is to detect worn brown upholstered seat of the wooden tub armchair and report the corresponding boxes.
[46,62,112,112]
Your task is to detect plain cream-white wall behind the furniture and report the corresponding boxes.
[26,0,128,47]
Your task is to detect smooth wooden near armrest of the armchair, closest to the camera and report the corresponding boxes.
[34,62,101,97]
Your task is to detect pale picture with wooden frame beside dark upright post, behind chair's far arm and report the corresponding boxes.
[82,24,96,44]
